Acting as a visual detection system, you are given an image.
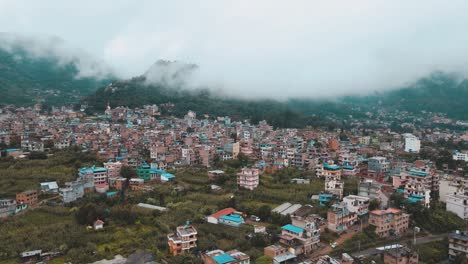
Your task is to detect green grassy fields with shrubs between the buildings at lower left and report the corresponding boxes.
[0,154,336,263]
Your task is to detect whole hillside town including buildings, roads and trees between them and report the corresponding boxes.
[0,104,468,264]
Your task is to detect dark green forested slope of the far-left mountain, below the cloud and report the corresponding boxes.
[0,34,113,106]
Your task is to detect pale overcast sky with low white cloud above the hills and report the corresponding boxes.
[0,0,468,98]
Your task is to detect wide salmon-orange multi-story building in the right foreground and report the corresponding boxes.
[369,208,409,237]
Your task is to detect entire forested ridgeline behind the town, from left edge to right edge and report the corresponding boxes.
[0,41,468,127]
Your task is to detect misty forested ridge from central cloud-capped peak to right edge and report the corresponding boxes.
[84,61,468,127]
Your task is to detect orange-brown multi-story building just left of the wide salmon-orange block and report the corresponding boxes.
[327,203,357,233]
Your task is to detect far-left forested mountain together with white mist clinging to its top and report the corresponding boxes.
[0,33,113,106]
